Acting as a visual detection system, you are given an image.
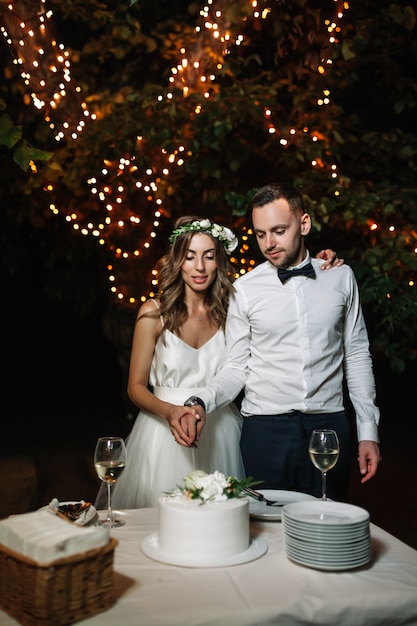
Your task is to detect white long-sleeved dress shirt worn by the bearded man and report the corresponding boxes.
[199,255,379,441]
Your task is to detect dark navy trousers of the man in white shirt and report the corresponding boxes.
[240,411,351,501]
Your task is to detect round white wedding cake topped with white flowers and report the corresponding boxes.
[158,470,249,559]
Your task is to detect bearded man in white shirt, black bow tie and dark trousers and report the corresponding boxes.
[180,184,381,500]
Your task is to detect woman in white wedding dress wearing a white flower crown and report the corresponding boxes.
[97,216,245,508]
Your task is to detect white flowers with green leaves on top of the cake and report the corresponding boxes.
[167,470,253,504]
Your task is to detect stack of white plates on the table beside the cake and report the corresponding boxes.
[282,500,372,570]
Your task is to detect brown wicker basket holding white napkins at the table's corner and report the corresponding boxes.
[0,539,117,626]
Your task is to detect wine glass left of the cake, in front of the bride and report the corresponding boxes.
[94,437,126,528]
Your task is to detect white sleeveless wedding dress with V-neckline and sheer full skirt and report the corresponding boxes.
[103,329,245,509]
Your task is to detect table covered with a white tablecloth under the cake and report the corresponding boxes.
[0,509,417,626]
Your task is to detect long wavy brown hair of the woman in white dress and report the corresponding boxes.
[157,215,234,335]
